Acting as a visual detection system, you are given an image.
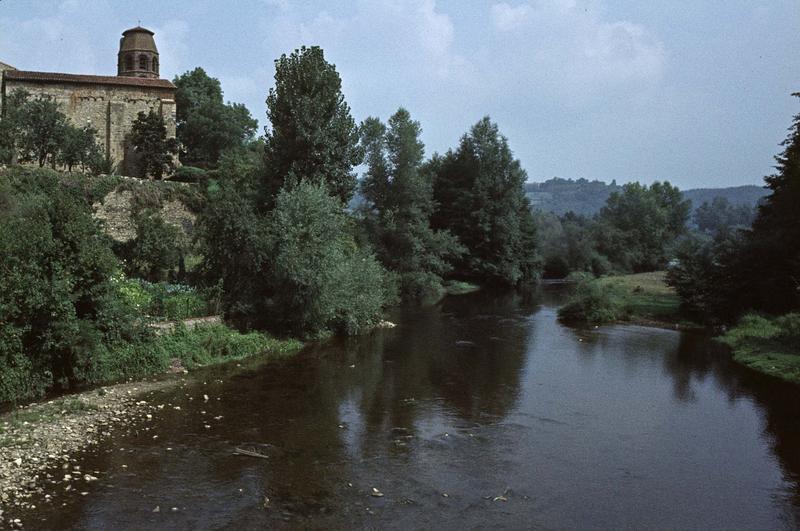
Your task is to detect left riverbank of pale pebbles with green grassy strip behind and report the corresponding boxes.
[0,323,303,527]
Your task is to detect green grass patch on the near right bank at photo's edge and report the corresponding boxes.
[717,313,800,384]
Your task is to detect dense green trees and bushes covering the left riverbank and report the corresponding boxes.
[0,47,540,410]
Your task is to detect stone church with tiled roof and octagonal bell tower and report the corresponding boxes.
[0,26,176,175]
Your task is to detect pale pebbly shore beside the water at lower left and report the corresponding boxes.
[0,378,180,528]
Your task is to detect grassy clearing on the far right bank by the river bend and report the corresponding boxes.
[559,271,680,324]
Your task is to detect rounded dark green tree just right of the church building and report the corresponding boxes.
[174,67,258,168]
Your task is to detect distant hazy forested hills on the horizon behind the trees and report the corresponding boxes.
[525,177,768,216]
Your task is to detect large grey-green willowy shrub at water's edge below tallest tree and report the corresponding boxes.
[268,182,391,336]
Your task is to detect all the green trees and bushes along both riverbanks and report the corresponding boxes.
[0,47,800,412]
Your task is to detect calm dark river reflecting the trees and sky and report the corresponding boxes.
[18,287,800,529]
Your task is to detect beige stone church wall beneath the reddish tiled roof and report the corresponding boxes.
[4,79,177,176]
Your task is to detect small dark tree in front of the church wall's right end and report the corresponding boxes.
[130,110,178,179]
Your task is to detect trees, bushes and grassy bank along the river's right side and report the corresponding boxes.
[556,94,800,382]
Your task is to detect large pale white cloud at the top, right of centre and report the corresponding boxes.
[483,0,667,100]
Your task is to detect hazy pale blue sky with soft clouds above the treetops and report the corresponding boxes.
[0,0,800,188]
